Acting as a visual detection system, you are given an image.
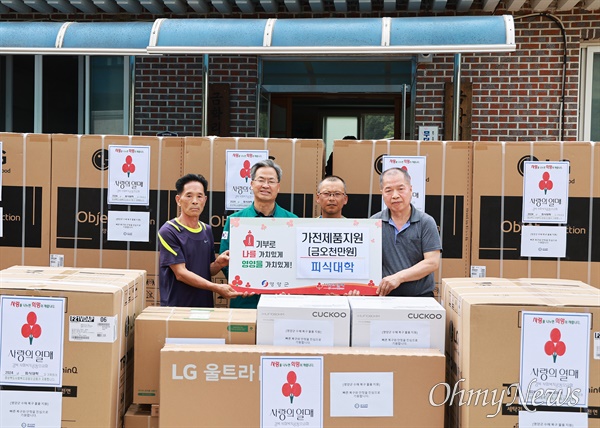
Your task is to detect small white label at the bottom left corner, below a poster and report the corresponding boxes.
[0,391,62,428]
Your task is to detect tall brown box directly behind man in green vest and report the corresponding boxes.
[184,137,325,251]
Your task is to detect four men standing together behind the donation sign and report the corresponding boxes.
[159,159,442,308]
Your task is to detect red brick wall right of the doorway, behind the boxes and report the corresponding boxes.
[415,10,600,141]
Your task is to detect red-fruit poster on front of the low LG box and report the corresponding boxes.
[260,356,323,428]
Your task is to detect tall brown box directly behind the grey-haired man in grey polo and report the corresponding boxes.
[333,140,473,295]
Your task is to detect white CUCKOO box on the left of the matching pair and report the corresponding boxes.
[256,294,350,346]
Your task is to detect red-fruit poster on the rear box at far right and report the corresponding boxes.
[523,161,569,224]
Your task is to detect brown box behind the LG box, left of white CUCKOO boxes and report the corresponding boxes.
[133,307,256,404]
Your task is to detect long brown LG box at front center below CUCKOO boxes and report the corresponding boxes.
[160,345,445,428]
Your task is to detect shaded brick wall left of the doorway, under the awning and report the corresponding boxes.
[134,55,258,137]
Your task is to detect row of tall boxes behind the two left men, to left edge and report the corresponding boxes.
[0,133,324,306]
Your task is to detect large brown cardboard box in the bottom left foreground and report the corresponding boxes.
[0,268,144,428]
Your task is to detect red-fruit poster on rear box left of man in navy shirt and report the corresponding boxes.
[107,144,150,205]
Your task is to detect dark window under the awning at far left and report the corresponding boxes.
[0,55,133,135]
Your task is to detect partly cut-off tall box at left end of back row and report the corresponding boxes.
[0,133,51,269]
